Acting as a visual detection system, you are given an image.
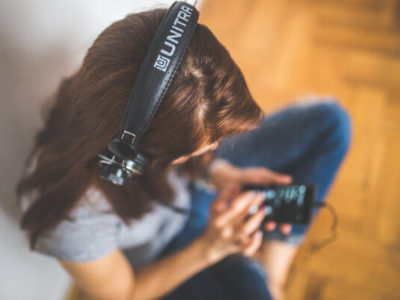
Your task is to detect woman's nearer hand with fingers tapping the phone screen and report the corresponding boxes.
[201,189,265,262]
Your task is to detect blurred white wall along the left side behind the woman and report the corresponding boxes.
[0,0,199,300]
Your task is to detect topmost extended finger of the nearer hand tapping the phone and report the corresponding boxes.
[214,191,263,228]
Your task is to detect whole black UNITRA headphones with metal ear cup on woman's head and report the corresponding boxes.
[97,1,199,185]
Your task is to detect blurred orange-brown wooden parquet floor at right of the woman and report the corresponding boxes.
[200,0,400,300]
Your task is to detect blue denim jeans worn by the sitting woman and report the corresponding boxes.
[160,99,352,300]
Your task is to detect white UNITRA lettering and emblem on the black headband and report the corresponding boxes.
[154,5,193,72]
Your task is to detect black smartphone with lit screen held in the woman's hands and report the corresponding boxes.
[243,184,317,225]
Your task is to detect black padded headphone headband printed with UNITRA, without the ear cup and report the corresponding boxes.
[108,1,199,159]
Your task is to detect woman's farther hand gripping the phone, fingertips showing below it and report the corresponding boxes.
[210,161,292,234]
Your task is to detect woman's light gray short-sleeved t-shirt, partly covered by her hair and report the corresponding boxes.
[23,169,190,265]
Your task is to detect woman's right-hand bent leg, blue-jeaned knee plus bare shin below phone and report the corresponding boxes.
[218,101,351,299]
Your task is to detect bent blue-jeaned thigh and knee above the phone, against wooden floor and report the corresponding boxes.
[217,100,351,201]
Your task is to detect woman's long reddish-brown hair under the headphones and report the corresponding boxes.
[16,9,263,248]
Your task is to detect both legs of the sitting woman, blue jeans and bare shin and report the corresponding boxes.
[158,101,350,300]
